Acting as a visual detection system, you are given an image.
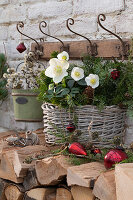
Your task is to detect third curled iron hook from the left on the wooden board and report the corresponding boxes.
[66,18,97,56]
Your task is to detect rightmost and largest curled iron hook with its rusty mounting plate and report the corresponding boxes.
[97,14,130,60]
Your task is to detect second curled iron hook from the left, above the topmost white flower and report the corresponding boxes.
[39,21,69,52]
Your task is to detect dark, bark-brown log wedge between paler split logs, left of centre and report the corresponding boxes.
[23,167,40,191]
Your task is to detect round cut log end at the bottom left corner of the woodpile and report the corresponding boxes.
[5,184,24,200]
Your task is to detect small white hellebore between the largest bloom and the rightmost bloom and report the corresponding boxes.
[71,67,84,81]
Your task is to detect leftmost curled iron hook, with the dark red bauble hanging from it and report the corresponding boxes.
[16,21,43,56]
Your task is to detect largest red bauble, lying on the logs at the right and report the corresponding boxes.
[104,149,127,169]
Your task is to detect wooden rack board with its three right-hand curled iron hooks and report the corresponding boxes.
[29,14,131,60]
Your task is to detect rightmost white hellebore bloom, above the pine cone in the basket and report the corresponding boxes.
[85,74,99,88]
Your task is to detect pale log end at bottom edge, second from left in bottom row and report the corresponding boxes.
[24,188,55,200]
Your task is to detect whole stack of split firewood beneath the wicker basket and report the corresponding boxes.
[0,130,133,200]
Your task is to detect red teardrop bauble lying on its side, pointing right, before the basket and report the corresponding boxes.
[69,142,87,156]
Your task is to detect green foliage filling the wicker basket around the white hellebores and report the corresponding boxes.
[38,52,133,113]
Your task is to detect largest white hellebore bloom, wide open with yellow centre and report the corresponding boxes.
[45,58,69,83]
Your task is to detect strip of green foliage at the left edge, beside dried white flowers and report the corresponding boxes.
[0,53,8,100]
